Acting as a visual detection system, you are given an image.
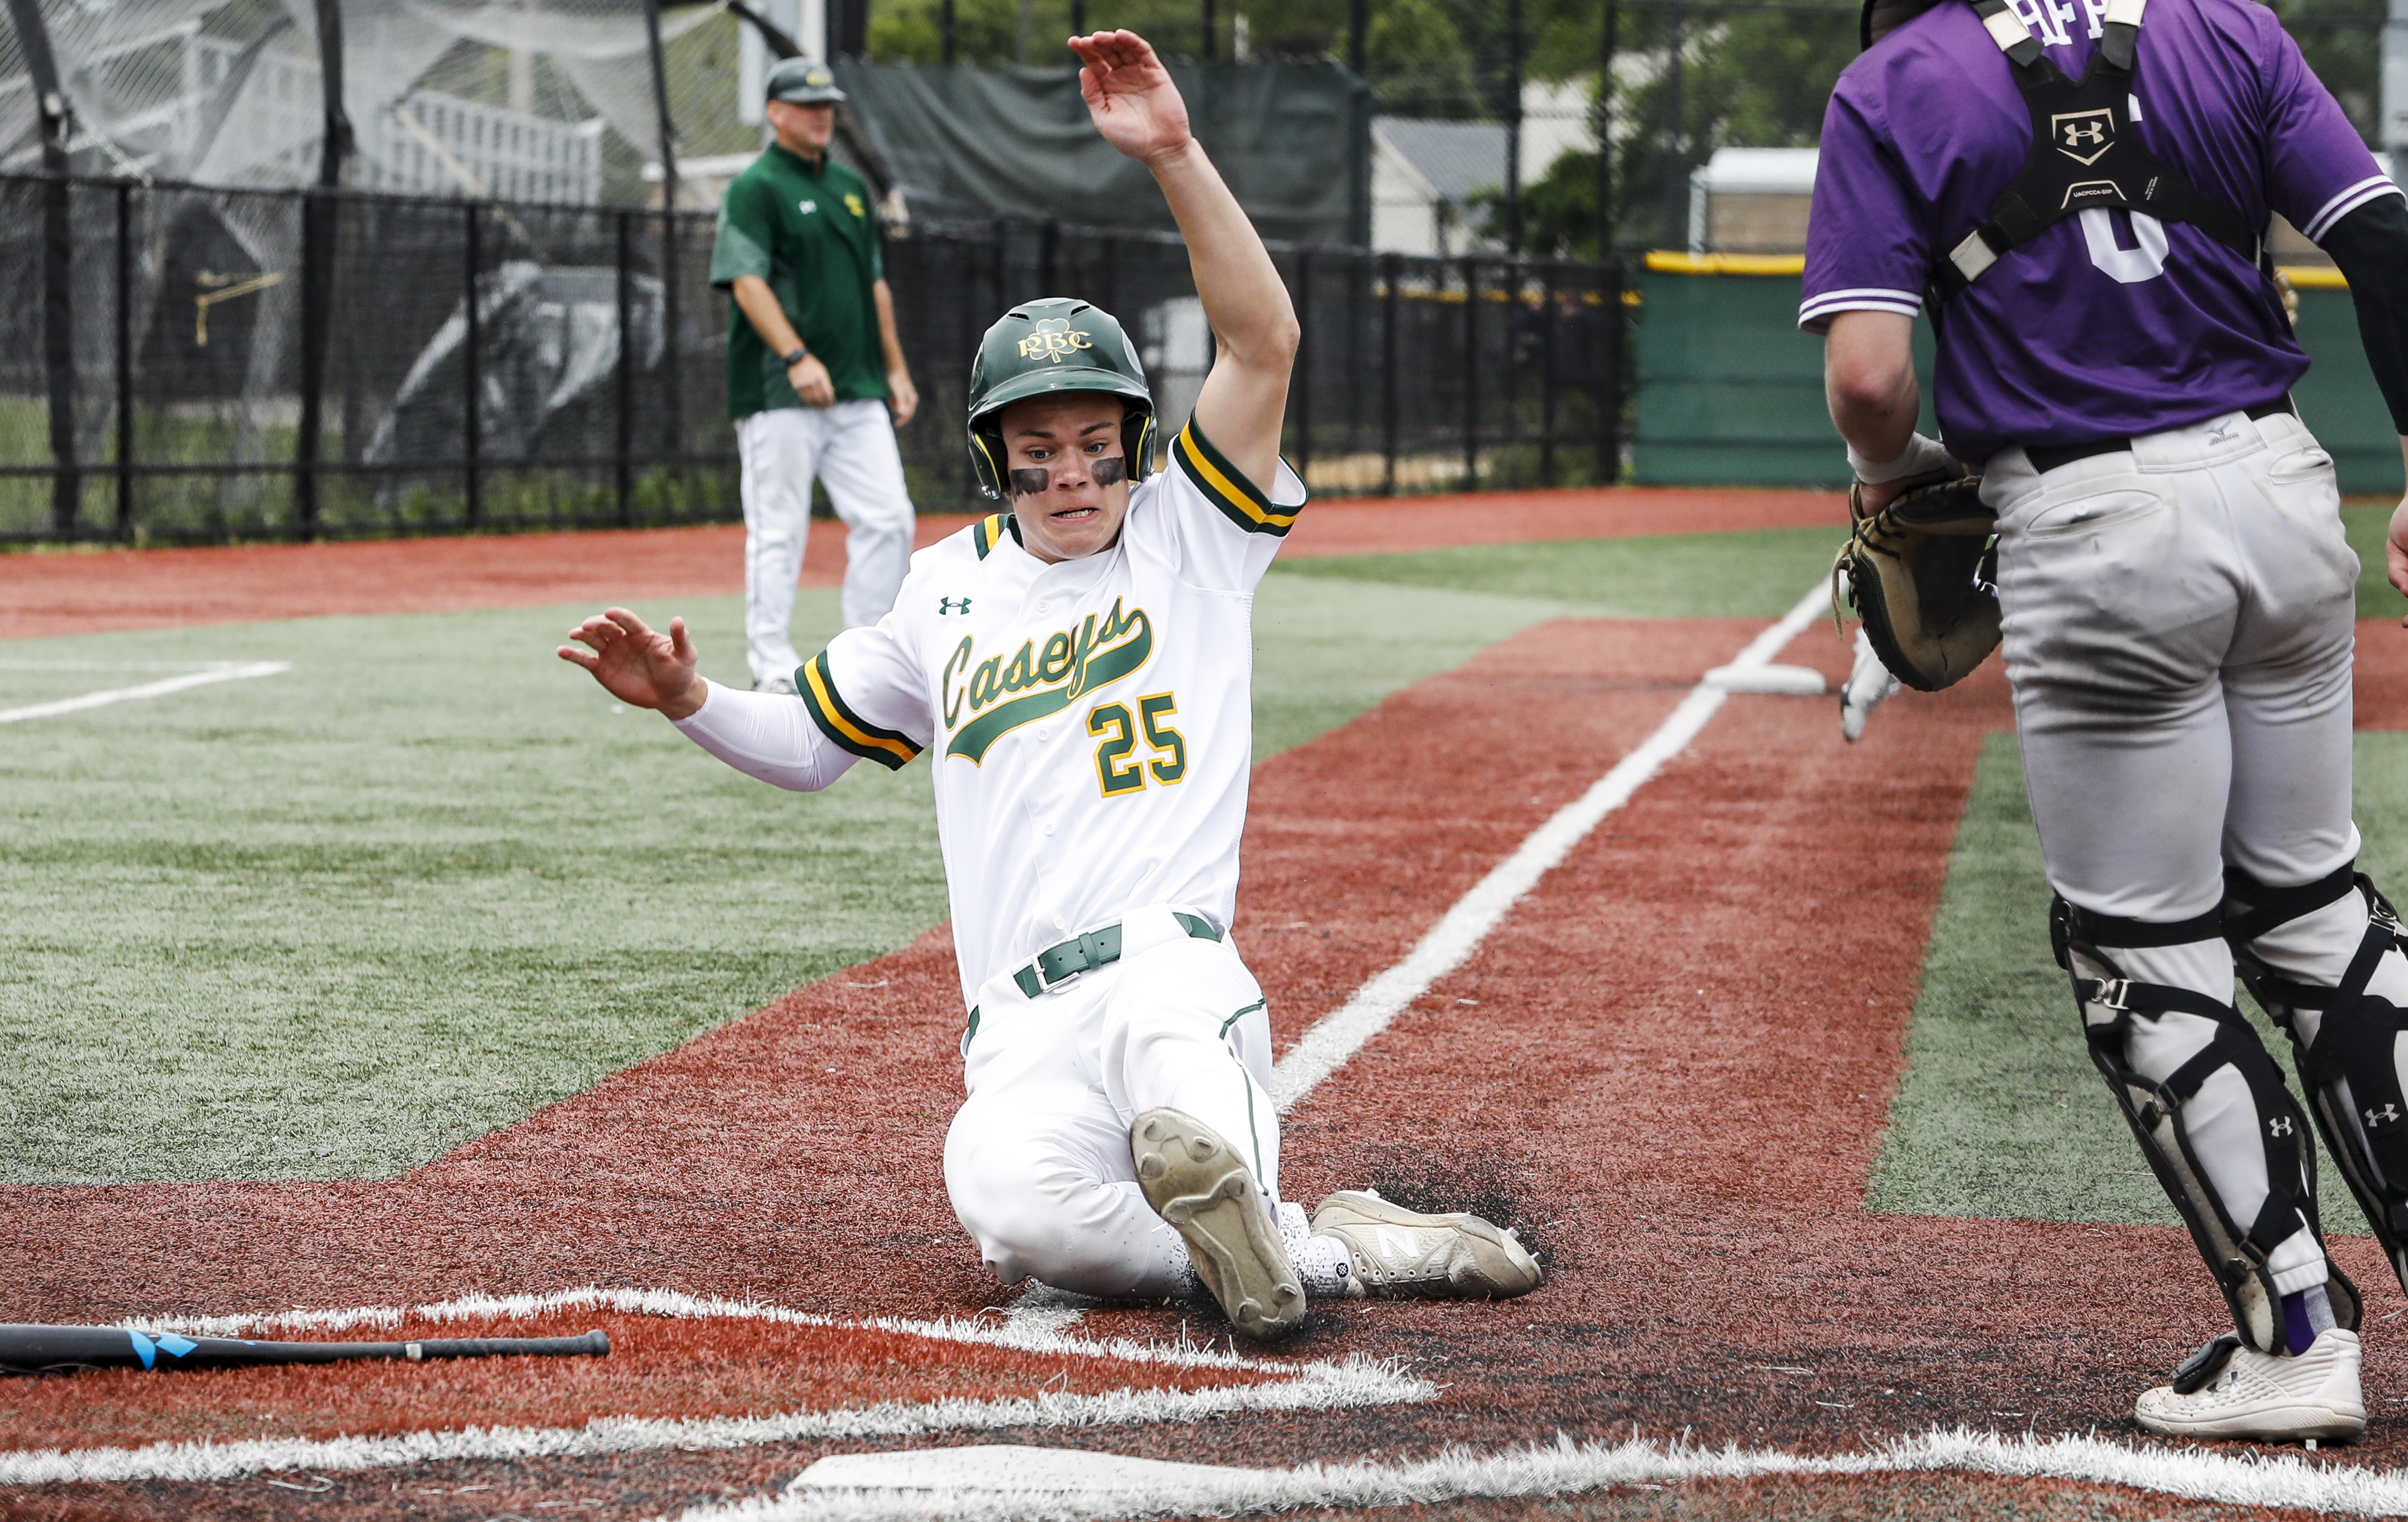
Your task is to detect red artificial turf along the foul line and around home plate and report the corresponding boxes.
[14,594,2408,1517]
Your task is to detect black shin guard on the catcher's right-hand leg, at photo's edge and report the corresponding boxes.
[2225,862,2408,1289]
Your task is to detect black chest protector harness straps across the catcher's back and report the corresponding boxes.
[1931,0,2266,306]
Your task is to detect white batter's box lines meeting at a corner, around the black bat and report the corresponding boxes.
[0,1286,1438,1486]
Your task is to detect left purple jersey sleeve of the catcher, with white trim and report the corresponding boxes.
[1799,89,1931,333]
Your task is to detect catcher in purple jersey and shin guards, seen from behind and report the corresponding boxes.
[1799,0,2408,1440]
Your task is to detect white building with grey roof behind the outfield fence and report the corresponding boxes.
[1370,80,1597,258]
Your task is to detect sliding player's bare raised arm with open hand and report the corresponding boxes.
[1069,31,1298,486]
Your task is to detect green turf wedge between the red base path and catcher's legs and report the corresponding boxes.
[1866,734,2408,1231]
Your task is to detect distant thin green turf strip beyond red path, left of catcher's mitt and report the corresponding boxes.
[1281,528,1847,619]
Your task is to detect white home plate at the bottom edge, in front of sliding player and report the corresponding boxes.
[787,1442,1269,1505]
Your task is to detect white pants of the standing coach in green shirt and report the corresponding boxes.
[737,400,913,681]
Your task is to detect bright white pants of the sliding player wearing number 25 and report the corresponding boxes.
[944,908,1278,1298]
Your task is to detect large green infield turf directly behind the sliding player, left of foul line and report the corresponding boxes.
[0,578,1599,1182]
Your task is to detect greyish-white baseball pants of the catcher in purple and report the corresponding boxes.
[1982,412,2369,1293]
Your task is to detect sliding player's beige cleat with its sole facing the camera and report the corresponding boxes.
[1130,1110,1305,1341]
